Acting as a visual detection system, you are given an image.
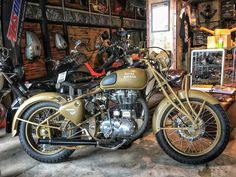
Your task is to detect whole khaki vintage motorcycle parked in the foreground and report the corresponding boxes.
[12,47,230,164]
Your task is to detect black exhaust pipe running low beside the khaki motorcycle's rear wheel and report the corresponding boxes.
[38,138,98,146]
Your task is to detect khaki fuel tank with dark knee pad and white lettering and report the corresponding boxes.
[100,68,148,90]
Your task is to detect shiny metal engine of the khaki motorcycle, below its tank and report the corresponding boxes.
[100,90,138,138]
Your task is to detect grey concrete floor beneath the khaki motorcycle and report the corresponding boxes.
[0,130,236,177]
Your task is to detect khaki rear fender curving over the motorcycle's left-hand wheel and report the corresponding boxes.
[12,92,67,136]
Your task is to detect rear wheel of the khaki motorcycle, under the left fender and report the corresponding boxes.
[19,102,74,163]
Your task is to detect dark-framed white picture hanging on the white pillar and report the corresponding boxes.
[151,1,170,32]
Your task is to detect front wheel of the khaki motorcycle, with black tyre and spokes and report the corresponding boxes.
[156,99,230,164]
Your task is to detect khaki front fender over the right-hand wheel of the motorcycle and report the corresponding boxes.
[152,90,219,134]
